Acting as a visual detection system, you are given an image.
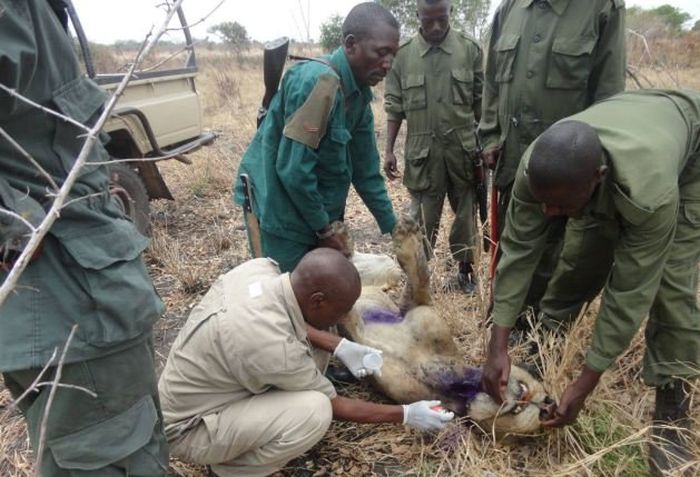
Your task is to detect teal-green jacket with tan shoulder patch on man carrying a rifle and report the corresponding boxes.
[235,48,396,245]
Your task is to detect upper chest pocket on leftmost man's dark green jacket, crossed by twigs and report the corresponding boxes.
[52,77,108,175]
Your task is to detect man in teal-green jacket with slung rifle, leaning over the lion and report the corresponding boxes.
[235,2,399,271]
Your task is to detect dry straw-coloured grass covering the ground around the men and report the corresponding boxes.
[0,43,700,477]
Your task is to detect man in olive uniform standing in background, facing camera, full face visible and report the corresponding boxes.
[384,0,483,293]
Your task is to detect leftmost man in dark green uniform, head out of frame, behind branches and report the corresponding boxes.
[0,0,168,477]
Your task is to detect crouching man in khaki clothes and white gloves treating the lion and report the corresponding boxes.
[159,248,453,476]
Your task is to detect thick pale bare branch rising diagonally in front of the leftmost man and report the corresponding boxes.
[0,0,183,306]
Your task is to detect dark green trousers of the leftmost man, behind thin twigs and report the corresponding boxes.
[3,339,168,477]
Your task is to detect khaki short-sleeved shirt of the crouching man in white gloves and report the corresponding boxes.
[158,258,336,439]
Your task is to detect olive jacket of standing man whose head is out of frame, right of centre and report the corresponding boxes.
[479,0,625,188]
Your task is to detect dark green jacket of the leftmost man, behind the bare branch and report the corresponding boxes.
[0,0,162,371]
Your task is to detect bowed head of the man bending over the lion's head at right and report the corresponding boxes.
[527,121,607,216]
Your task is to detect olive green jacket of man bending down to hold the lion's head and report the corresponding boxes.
[493,90,700,371]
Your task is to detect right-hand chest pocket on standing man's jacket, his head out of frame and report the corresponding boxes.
[546,37,596,89]
